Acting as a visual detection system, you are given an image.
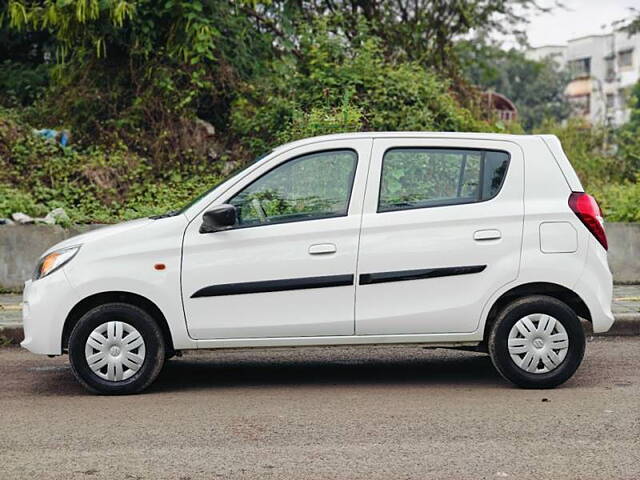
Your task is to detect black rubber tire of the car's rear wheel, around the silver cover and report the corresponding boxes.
[488,295,585,389]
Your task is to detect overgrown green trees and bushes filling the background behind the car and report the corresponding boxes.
[0,0,640,222]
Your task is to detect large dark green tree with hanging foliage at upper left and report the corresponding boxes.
[7,0,271,159]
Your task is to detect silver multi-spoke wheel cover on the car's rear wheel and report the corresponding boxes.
[508,313,569,373]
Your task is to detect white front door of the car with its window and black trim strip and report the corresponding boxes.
[182,139,372,339]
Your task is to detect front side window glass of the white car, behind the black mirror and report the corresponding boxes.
[228,150,358,226]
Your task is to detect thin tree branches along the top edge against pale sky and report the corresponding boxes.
[242,0,546,70]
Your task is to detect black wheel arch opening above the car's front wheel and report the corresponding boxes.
[62,291,174,352]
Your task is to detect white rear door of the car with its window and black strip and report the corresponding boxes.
[356,138,524,335]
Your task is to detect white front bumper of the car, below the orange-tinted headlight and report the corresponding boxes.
[20,270,76,355]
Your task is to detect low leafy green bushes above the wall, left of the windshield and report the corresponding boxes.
[0,110,222,223]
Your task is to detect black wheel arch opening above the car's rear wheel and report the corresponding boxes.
[483,282,591,342]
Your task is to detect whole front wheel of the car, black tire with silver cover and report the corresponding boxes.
[69,303,166,395]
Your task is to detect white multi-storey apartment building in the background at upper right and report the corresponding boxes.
[526,31,640,126]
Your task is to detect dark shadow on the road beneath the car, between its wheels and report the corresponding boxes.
[151,349,507,392]
